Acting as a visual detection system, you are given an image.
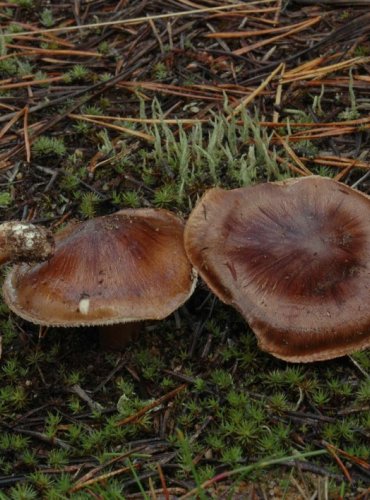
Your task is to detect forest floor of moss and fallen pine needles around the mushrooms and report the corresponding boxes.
[0,0,370,500]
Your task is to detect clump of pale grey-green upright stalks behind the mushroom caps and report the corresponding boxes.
[144,100,281,204]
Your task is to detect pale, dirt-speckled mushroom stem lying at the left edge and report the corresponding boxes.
[0,221,54,265]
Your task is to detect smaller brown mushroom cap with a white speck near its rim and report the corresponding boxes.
[3,209,196,326]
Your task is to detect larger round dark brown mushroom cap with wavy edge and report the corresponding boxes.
[185,176,370,362]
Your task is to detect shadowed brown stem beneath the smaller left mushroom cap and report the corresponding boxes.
[99,321,143,351]
